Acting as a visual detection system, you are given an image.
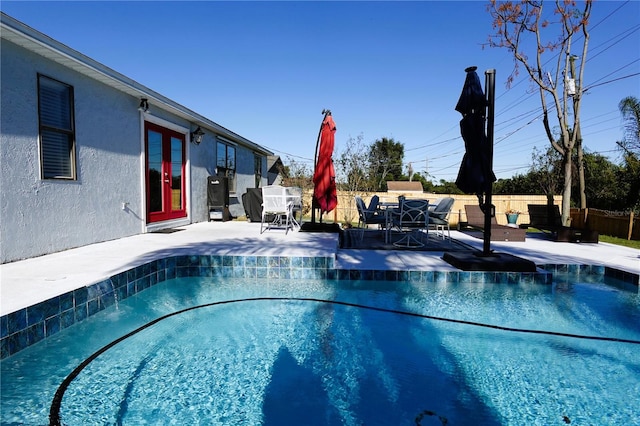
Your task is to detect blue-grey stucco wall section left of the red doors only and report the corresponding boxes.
[0,40,142,262]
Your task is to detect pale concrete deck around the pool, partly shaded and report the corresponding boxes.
[0,221,640,315]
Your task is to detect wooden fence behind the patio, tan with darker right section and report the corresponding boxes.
[304,191,640,240]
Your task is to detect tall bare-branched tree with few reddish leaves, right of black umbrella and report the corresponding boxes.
[487,0,592,225]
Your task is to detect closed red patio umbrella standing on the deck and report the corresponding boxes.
[313,111,338,221]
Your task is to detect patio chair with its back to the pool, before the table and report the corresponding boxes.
[391,199,429,248]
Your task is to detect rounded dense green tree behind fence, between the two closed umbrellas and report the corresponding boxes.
[369,137,404,191]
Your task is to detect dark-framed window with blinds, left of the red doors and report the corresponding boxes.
[38,75,76,179]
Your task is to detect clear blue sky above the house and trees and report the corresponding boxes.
[0,0,640,182]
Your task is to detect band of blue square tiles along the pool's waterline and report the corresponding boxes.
[0,254,639,359]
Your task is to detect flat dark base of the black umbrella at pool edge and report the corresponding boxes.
[442,251,536,272]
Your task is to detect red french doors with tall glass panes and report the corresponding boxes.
[144,122,187,223]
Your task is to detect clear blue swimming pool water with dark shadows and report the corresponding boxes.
[1,277,640,425]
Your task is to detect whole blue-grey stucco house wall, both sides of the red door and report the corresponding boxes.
[0,30,267,263]
